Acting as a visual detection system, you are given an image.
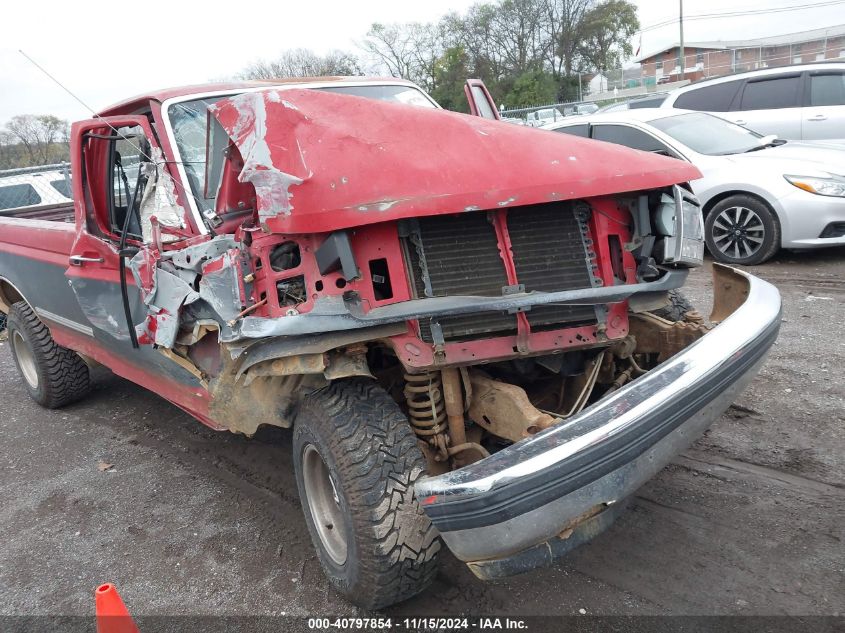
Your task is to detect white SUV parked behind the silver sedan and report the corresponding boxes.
[660,62,845,143]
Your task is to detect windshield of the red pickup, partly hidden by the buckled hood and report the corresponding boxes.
[167,85,437,212]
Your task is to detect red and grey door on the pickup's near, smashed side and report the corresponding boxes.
[65,116,206,387]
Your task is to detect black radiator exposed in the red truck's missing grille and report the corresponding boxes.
[403,202,596,342]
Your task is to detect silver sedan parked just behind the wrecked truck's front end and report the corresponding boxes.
[546,108,845,265]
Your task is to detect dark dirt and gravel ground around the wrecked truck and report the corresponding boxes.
[0,249,845,616]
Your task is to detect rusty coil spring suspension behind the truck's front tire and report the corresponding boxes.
[403,371,449,461]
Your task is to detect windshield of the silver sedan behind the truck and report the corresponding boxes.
[649,112,762,156]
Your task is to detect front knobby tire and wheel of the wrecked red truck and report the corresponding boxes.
[293,378,441,609]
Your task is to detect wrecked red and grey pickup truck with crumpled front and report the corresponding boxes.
[0,79,780,607]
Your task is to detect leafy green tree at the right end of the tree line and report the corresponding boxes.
[580,0,640,72]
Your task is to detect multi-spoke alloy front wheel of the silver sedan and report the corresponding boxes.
[704,195,781,266]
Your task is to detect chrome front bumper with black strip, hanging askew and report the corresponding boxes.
[416,264,781,577]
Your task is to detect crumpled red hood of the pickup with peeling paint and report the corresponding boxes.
[212,89,701,233]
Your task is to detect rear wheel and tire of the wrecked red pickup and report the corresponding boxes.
[6,301,91,409]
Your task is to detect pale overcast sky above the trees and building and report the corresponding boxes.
[0,0,845,122]
